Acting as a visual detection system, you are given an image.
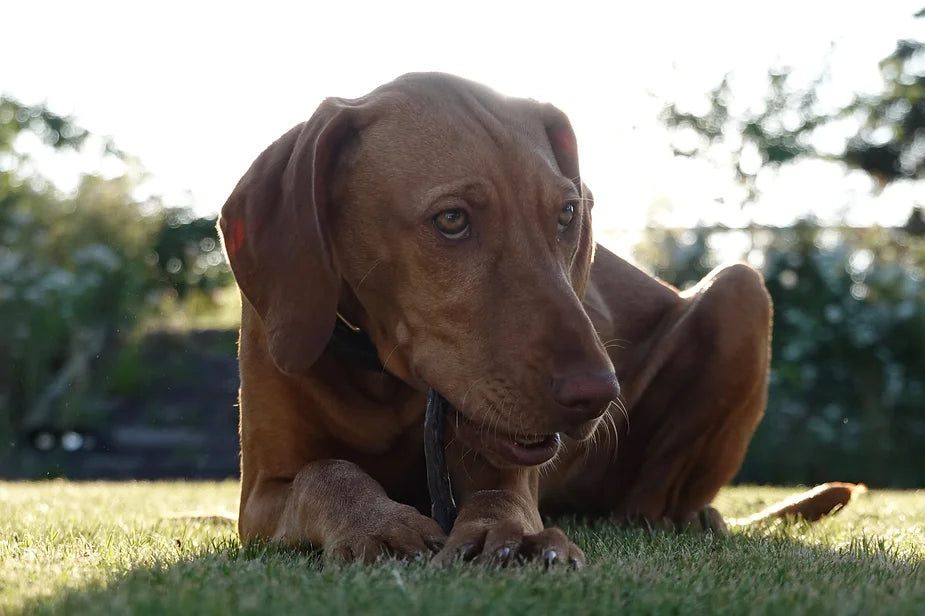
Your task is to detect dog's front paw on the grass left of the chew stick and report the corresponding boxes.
[324,503,446,563]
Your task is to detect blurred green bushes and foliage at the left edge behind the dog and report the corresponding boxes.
[0,97,231,466]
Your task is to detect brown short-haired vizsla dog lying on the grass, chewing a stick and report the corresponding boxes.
[220,73,860,565]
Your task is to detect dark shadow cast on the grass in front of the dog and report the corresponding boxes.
[26,524,925,616]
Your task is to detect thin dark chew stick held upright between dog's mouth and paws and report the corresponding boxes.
[424,388,456,535]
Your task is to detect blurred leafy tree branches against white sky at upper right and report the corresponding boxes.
[662,9,925,214]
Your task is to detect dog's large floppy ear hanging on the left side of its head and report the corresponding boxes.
[219,99,352,373]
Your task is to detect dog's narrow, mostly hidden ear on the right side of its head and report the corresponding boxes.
[545,104,594,297]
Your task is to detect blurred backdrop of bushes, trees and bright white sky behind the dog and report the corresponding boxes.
[0,0,925,487]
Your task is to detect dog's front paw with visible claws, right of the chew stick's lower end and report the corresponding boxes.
[433,520,585,569]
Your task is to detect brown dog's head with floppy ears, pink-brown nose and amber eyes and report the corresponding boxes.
[221,74,618,465]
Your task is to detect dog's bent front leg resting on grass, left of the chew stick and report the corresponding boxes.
[239,460,446,562]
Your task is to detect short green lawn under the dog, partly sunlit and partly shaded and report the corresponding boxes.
[0,481,925,616]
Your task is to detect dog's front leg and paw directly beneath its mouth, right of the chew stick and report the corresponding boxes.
[434,468,585,567]
